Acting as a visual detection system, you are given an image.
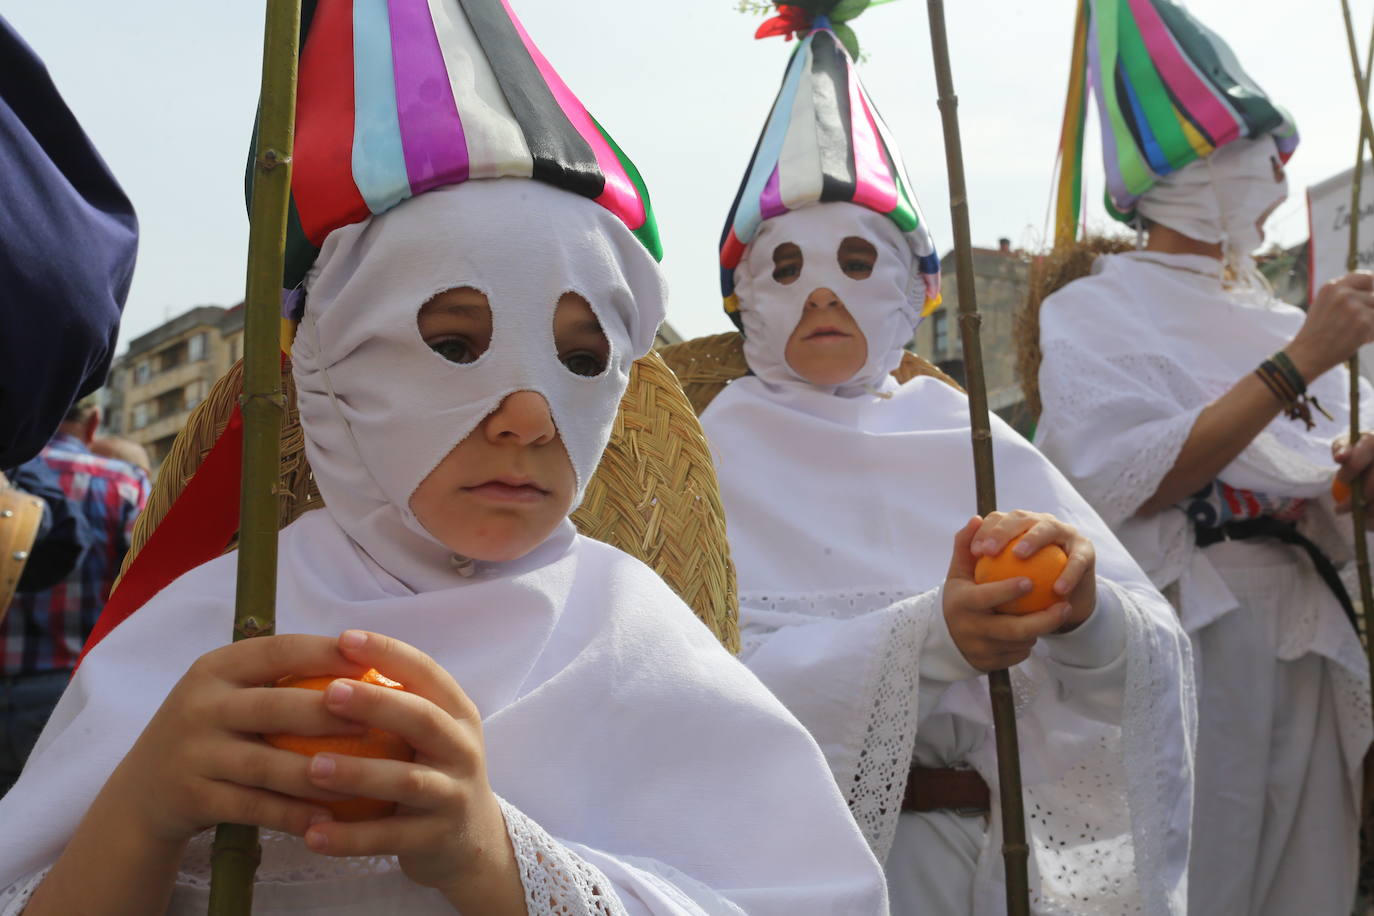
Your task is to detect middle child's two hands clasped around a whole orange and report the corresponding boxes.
[944,511,1096,672]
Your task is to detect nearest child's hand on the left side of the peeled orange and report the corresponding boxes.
[102,634,365,847]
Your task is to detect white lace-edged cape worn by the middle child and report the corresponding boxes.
[702,378,1194,915]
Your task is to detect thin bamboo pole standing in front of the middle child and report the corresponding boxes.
[927,0,1031,916]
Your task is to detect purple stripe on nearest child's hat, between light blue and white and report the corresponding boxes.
[387,0,467,194]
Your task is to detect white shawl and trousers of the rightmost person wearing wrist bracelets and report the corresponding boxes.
[1037,251,1371,913]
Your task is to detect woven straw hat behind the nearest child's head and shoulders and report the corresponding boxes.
[121,353,739,652]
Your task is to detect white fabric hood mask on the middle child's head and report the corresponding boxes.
[735,202,925,397]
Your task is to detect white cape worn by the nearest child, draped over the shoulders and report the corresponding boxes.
[0,511,886,916]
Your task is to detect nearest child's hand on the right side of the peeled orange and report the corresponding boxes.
[305,630,523,912]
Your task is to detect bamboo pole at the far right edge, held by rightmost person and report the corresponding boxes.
[1341,0,1374,895]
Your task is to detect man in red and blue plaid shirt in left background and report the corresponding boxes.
[0,402,150,795]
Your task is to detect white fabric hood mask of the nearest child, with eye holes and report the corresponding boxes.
[291,179,665,592]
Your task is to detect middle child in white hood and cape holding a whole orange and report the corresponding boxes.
[702,5,1191,915]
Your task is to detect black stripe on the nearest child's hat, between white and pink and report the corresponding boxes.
[459,0,606,199]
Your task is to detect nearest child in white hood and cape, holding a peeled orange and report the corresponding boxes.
[0,3,886,916]
